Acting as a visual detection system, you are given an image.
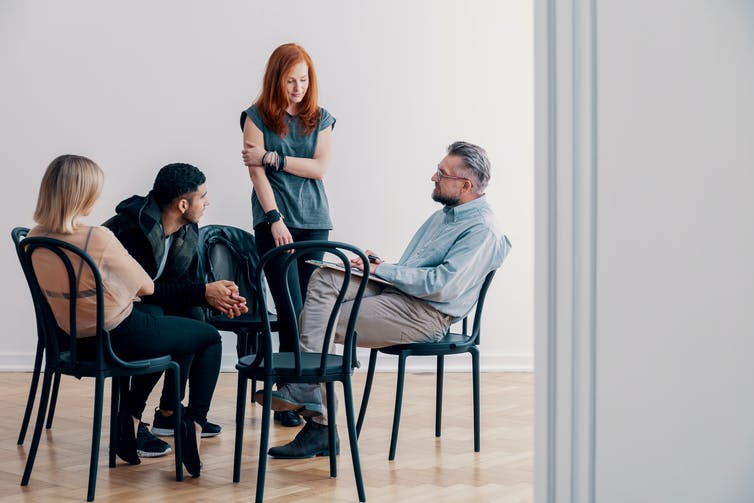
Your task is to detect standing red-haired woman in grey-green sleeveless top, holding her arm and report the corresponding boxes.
[241,44,335,426]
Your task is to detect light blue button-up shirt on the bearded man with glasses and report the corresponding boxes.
[376,196,511,319]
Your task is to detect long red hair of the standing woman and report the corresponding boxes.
[256,44,320,136]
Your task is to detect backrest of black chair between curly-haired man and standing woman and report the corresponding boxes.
[198,225,265,314]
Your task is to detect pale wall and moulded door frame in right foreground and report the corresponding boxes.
[536,0,754,503]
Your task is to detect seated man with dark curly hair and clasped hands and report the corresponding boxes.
[103,163,246,457]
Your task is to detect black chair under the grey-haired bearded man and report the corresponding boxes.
[356,271,495,461]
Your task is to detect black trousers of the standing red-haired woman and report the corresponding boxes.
[254,223,330,352]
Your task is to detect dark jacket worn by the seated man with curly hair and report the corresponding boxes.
[103,195,207,309]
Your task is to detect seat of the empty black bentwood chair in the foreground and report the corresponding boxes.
[236,353,343,382]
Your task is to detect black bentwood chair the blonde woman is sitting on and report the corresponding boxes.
[19,237,183,501]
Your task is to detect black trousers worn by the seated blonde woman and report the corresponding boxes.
[110,302,222,427]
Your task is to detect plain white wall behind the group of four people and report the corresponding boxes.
[0,0,533,369]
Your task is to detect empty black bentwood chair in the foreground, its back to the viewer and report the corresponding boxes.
[233,241,369,503]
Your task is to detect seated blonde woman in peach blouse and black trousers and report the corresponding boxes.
[29,155,229,477]
